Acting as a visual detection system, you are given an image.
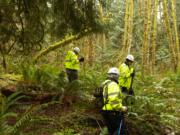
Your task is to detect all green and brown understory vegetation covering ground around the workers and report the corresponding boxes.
[0,65,180,135]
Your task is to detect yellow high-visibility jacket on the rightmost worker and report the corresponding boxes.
[119,63,134,90]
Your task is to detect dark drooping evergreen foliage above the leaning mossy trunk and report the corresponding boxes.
[0,0,106,53]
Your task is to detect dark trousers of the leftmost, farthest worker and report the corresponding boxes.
[66,68,78,82]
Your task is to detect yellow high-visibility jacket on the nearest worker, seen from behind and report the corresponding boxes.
[102,80,122,111]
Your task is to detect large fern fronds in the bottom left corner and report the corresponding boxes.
[0,92,45,135]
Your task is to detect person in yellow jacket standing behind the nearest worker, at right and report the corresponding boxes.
[119,54,135,95]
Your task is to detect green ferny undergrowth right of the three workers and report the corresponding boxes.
[128,73,180,135]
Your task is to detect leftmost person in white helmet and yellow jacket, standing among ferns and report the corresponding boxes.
[65,47,84,82]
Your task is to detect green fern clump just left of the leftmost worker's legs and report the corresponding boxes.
[21,64,67,91]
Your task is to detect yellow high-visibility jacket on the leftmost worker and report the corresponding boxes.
[65,51,79,70]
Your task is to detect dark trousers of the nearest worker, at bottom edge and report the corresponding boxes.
[101,111,127,135]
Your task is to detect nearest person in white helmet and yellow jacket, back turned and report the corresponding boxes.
[101,67,127,135]
